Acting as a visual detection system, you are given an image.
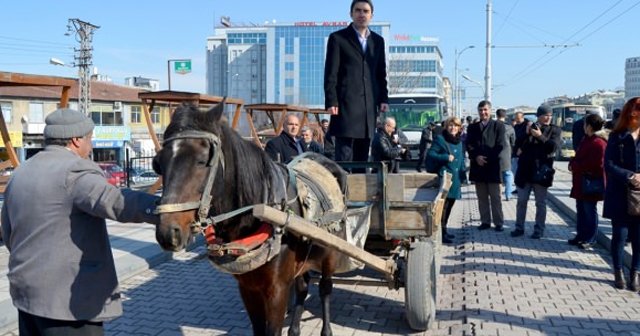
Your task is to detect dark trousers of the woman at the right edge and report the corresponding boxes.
[611,220,640,271]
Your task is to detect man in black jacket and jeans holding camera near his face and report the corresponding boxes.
[511,104,561,239]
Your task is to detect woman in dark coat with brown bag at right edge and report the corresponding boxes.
[603,97,640,292]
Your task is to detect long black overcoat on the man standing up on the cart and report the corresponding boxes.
[324,24,389,139]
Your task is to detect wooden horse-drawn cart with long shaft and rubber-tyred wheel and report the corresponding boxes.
[254,163,451,330]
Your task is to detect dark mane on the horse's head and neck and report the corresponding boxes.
[164,104,273,213]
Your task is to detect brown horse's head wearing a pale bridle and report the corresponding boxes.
[153,103,224,251]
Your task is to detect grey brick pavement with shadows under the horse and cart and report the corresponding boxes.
[1,182,640,336]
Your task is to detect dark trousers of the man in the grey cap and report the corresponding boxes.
[18,310,104,336]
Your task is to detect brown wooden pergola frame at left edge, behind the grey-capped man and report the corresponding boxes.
[0,71,75,193]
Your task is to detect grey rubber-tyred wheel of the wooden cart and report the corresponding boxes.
[404,241,436,331]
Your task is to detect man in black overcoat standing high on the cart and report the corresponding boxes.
[324,0,389,161]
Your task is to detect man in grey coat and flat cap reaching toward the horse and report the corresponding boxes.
[2,108,159,335]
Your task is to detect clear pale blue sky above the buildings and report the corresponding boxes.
[0,0,640,110]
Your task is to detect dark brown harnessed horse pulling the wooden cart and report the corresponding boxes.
[153,102,346,336]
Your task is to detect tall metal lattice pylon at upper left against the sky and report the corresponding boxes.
[66,19,100,115]
